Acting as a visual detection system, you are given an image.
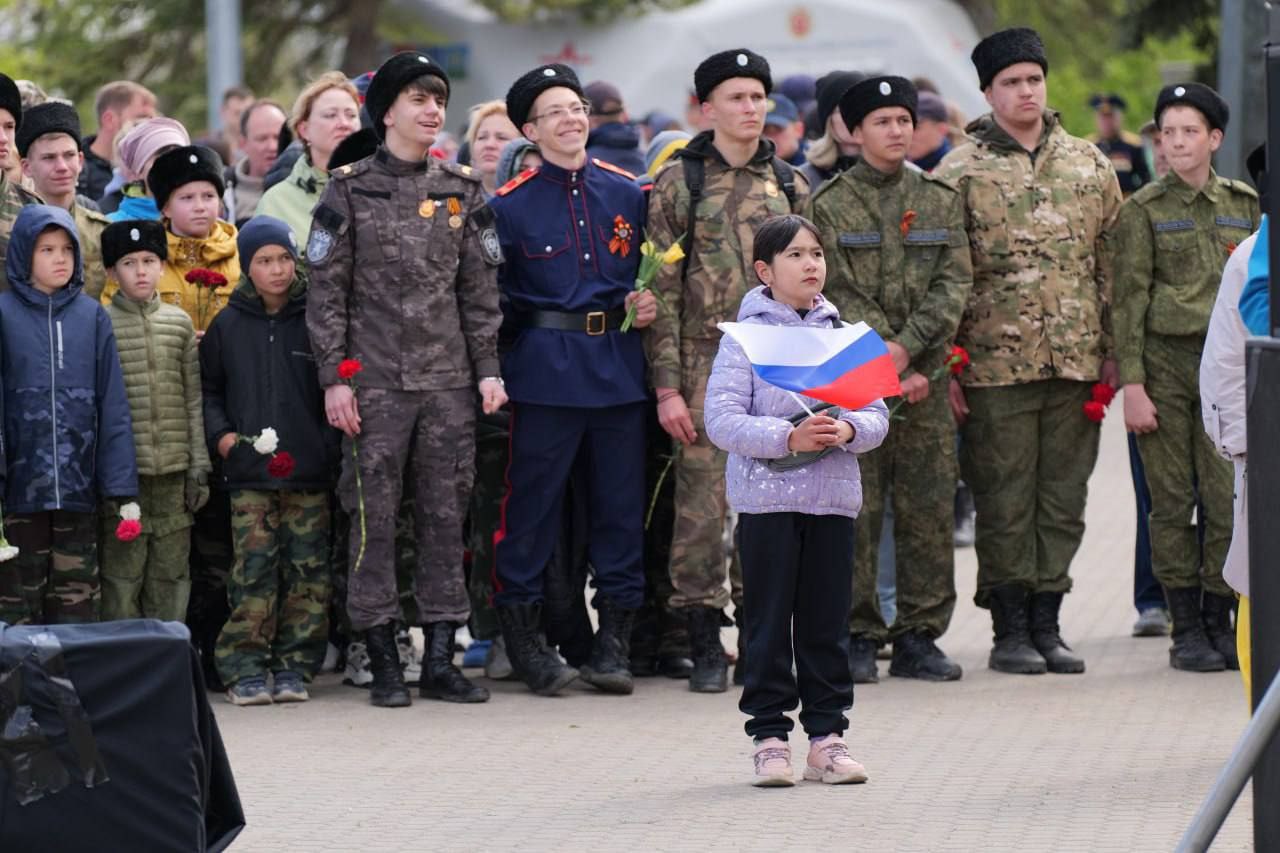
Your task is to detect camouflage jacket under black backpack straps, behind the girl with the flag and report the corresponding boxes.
[644,132,809,388]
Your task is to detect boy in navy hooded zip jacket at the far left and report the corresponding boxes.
[0,205,138,625]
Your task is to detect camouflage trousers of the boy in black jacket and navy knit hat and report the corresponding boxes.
[214,489,329,685]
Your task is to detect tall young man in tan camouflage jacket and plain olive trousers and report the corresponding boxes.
[934,28,1121,674]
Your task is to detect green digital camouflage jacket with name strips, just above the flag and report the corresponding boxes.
[809,161,973,375]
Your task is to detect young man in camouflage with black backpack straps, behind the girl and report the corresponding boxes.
[645,47,808,693]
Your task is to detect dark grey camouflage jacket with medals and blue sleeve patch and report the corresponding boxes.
[306,147,502,391]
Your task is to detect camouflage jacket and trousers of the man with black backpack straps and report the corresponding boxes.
[644,132,809,608]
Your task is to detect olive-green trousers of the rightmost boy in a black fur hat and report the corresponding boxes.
[1138,333,1235,596]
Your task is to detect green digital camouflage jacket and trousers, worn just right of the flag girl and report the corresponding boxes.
[809,161,973,643]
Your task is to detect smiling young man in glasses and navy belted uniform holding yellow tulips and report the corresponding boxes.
[489,64,657,695]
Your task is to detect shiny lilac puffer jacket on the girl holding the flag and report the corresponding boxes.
[703,287,888,517]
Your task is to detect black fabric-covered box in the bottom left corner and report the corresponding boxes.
[0,620,244,853]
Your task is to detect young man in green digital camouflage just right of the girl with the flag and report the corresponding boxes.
[809,77,973,683]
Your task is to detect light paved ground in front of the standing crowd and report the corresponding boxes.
[215,411,1252,853]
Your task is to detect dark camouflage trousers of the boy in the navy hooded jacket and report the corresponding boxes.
[0,510,101,625]
